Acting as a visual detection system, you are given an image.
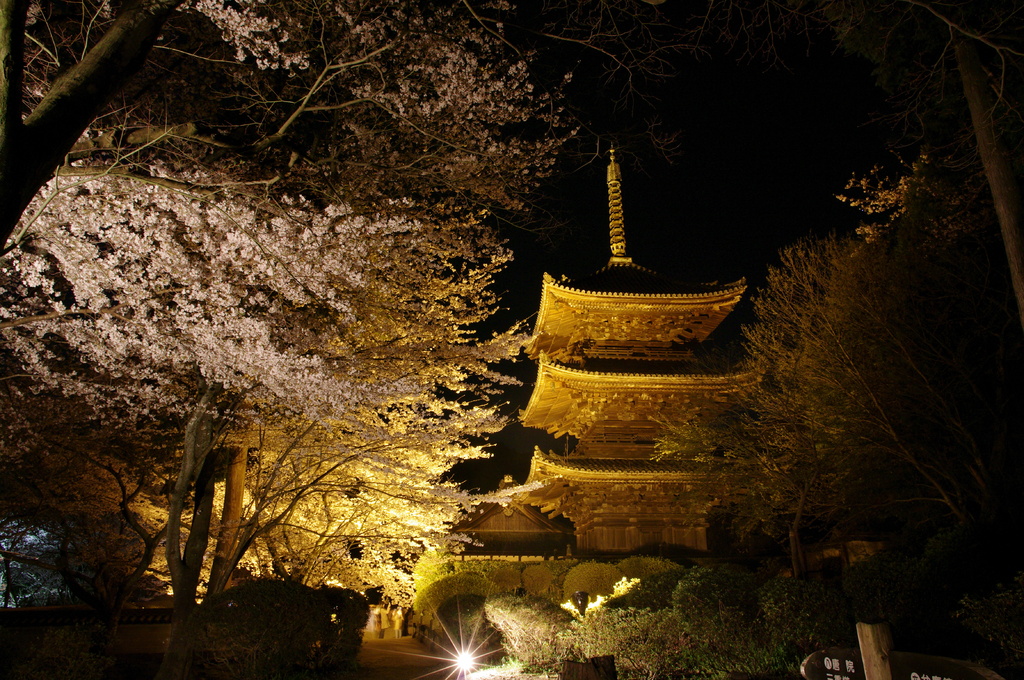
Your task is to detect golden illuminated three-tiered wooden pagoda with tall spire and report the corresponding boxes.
[521,153,745,555]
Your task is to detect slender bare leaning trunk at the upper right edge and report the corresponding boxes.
[956,39,1024,328]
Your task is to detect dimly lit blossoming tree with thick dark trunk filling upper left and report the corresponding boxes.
[0,0,570,247]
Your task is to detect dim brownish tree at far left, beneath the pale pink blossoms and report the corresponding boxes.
[0,387,173,635]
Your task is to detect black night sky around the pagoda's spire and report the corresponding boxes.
[453,42,892,491]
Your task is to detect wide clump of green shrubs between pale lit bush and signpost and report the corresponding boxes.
[566,566,854,679]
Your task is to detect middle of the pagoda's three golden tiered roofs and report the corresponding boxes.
[521,354,753,437]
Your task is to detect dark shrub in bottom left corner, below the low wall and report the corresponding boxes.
[0,626,114,680]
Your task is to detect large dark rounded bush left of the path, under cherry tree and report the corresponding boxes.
[188,581,369,679]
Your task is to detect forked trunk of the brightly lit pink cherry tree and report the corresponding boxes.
[157,385,221,680]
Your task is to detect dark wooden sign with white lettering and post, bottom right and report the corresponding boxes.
[800,624,1004,680]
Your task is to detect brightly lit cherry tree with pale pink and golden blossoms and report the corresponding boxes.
[0,175,518,677]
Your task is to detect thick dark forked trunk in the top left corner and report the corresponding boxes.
[0,0,182,249]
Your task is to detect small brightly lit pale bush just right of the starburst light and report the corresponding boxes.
[484,595,572,671]
